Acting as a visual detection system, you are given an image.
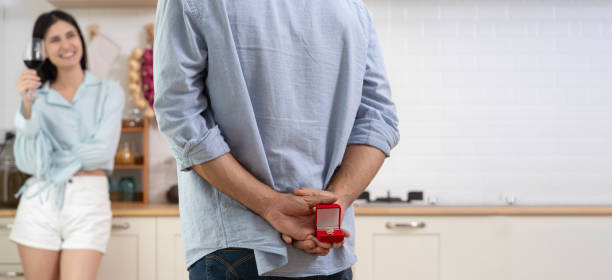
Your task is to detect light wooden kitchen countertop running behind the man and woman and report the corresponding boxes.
[0,204,612,217]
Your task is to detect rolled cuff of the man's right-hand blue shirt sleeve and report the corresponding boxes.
[347,120,399,157]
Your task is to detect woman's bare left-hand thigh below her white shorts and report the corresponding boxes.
[17,244,60,280]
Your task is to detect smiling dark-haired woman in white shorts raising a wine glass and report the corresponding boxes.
[10,10,125,280]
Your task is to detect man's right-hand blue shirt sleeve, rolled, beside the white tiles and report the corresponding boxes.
[348,9,399,156]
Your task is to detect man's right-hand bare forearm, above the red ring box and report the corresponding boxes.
[327,145,385,207]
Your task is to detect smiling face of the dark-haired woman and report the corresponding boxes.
[45,20,83,70]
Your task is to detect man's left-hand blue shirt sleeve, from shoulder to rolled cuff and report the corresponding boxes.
[153,0,230,170]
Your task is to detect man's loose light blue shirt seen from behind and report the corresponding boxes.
[154,0,399,277]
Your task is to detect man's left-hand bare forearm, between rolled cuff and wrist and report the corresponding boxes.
[192,153,277,216]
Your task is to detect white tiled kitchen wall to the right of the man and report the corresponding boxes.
[365,0,612,203]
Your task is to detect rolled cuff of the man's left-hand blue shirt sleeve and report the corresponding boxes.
[172,127,230,171]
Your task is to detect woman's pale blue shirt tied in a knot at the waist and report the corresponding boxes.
[14,72,125,207]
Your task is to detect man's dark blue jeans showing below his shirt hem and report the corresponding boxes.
[189,248,353,280]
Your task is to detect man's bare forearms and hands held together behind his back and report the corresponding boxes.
[192,145,385,255]
